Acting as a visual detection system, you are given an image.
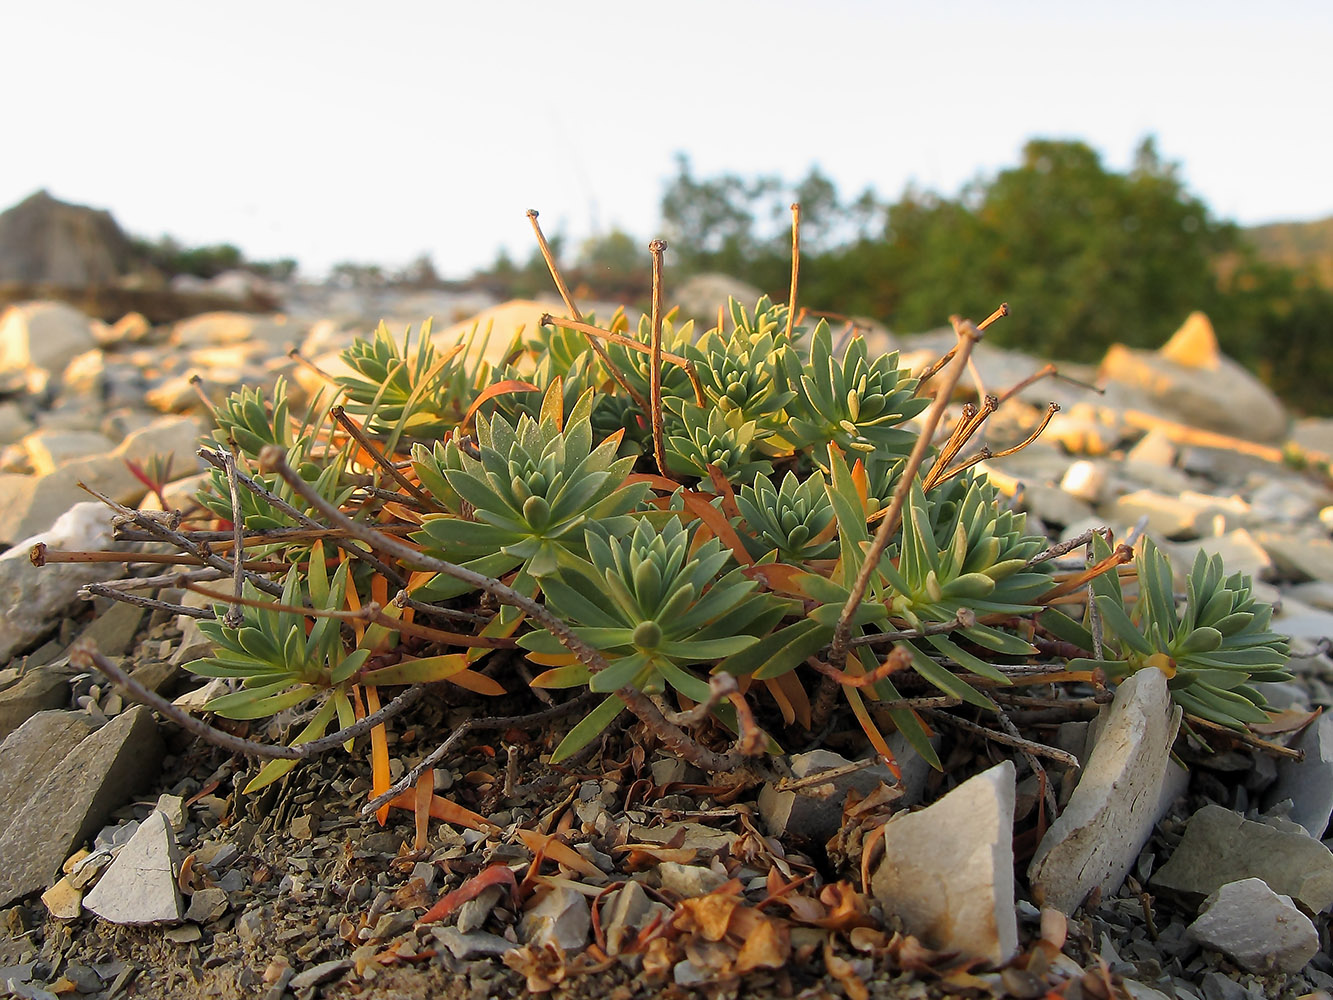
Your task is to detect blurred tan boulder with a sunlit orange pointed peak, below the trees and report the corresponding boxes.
[1100,312,1288,443]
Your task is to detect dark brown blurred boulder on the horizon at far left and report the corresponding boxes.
[0,191,136,288]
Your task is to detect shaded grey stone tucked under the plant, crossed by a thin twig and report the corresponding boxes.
[758,733,930,844]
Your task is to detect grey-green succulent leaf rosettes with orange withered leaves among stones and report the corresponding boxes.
[163,280,1285,805]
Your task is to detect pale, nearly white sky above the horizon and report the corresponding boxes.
[0,0,1333,277]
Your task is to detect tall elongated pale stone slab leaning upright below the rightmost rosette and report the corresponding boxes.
[1028,667,1181,913]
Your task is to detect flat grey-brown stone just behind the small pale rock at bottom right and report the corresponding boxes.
[1152,804,1333,913]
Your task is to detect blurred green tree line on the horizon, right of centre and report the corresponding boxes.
[475,137,1333,413]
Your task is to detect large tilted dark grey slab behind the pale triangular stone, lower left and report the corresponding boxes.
[0,705,163,907]
